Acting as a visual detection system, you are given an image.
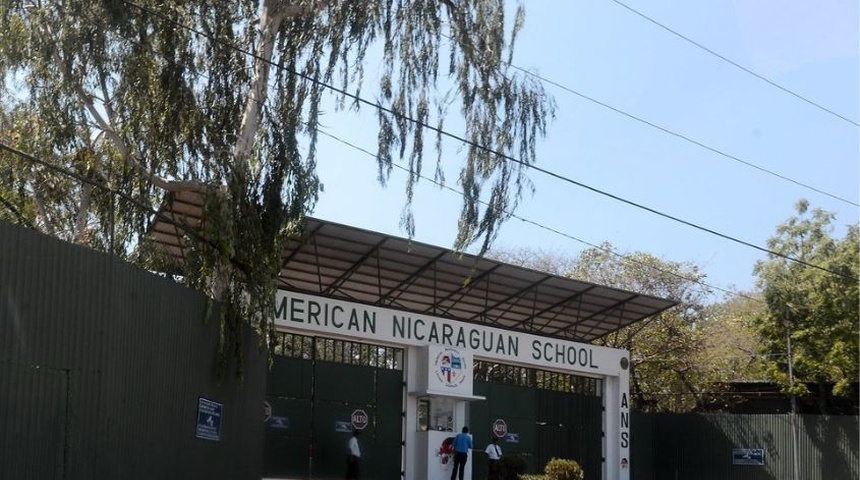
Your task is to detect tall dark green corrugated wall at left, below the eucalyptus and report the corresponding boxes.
[0,222,266,480]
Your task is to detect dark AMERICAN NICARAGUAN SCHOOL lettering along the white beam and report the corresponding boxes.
[275,296,598,370]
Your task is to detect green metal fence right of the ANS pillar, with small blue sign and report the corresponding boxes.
[631,413,860,480]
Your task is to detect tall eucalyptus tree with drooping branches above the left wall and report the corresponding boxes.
[0,0,555,372]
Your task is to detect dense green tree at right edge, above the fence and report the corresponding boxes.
[755,200,860,404]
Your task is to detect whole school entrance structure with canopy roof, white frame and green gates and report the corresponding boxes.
[146,208,675,480]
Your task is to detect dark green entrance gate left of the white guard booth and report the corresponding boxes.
[263,333,403,479]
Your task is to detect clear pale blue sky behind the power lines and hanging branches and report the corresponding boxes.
[306,0,860,300]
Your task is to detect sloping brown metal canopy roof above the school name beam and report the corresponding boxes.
[151,192,677,342]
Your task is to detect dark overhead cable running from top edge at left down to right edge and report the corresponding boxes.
[107,0,857,281]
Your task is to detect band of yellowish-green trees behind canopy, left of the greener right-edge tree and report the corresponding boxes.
[490,243,788,412]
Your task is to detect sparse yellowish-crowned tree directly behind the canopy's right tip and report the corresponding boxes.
[568,243,715,412]
